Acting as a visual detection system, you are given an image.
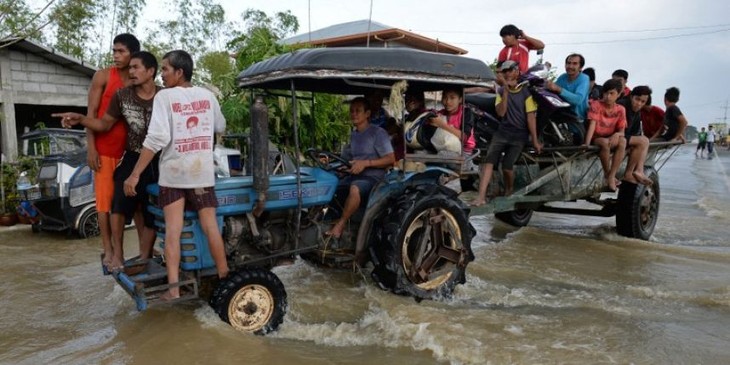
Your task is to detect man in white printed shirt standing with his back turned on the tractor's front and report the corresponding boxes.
[124,50,228,300]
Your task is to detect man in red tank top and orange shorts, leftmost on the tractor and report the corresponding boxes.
[86,33,141,269]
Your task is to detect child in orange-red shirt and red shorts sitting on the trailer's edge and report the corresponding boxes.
[583,79,626,191]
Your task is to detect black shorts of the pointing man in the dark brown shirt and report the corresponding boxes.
[112,151,159,228]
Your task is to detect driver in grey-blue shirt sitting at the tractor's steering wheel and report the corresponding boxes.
[326,97,395,238]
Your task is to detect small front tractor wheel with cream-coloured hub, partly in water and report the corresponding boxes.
[210,269,287,335]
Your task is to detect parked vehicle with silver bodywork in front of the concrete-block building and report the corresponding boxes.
[21,128,99,238]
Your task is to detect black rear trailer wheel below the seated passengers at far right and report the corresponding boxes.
[616,167,659,240]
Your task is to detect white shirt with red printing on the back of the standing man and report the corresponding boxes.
[143,86,226,189]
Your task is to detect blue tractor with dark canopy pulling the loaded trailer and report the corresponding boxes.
[114,48,494,334]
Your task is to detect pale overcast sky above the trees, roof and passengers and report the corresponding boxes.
[171,0,730,127]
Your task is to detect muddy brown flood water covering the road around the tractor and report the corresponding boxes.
[0,146,730,364]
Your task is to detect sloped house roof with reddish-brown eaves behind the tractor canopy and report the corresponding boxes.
[281,19,467,55]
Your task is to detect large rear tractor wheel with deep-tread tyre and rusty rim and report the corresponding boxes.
[372,185,475,300]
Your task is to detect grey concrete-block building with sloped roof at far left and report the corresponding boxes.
[0,39,96,161]
